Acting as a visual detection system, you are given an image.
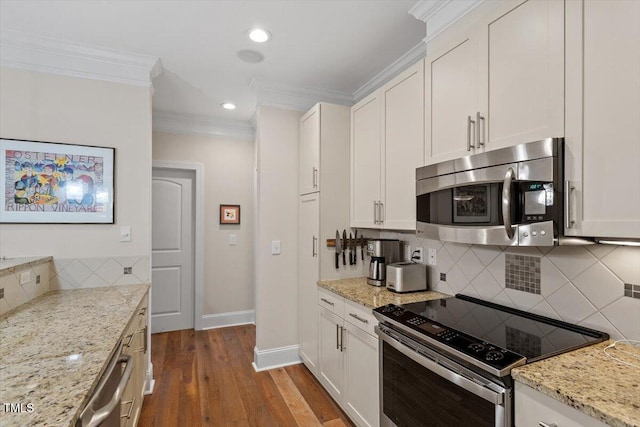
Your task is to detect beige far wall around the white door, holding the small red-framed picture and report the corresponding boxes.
[153,132,254,315]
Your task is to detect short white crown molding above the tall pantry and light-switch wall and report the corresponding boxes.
[249,79,353,111]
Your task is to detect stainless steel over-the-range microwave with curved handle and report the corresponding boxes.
[416,138,587,246]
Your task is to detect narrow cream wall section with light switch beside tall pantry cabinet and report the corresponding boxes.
[256,107,302,358]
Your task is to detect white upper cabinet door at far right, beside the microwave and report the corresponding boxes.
[565,0,640,239]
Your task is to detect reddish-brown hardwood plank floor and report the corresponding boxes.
[138,325,353,427]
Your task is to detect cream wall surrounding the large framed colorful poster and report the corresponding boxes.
[0,67,151,260]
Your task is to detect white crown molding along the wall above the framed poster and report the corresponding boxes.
[0,30,162,88]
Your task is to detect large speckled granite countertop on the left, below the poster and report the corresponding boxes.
[0,284,149,426]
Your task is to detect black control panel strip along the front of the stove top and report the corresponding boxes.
[374,304,523,369]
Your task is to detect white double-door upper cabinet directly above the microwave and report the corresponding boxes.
[425,0,564,164]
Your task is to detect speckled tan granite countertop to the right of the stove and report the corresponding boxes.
[511,341,640,427]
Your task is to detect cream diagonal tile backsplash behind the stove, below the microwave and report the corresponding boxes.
[380,232,640,340]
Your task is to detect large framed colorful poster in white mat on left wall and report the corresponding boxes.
[0,139,115,224]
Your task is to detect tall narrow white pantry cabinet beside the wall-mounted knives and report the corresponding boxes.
[298,102,352,375]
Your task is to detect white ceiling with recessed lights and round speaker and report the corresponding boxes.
[0,0,426,127]
